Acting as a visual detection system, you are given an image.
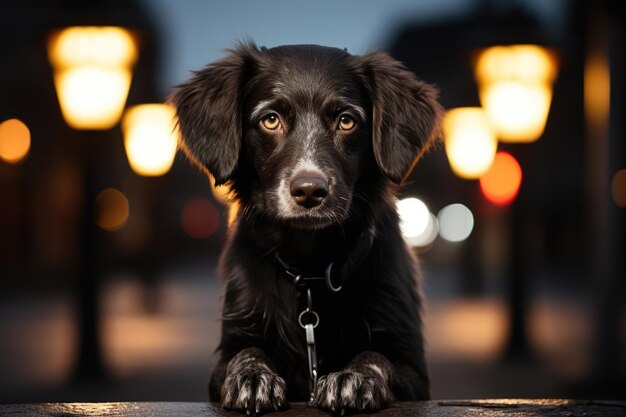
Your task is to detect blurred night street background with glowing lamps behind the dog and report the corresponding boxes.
[0,0,626,403]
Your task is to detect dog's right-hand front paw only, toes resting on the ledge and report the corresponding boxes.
[315,370,390,415]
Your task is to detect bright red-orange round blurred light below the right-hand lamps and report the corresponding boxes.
[480,152,522,206]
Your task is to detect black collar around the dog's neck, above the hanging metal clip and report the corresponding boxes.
[274,225,376,292]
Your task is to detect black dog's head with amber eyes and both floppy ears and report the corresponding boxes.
[171,43,442,228]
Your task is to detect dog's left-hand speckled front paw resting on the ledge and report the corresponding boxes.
[221,369,287,415]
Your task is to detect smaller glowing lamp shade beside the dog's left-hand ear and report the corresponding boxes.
[122,104,177,177]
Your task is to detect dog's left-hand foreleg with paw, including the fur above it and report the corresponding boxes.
[221,348,287,415]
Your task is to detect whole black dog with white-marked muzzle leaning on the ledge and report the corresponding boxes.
[171,43,442,413]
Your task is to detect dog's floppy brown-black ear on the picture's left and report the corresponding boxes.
[169,43,258,185]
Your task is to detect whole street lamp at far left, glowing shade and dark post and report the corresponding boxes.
[48,26,138,380]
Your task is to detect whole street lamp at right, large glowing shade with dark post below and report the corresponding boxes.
[474,44,557,358]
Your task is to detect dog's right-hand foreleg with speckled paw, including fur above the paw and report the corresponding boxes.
[315,352,393,415]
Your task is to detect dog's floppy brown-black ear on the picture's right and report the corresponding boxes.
[357,51,443,184]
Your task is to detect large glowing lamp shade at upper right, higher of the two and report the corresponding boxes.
[475,45,557,142]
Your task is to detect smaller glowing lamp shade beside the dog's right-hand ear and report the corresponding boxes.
[443,107,498,179]
